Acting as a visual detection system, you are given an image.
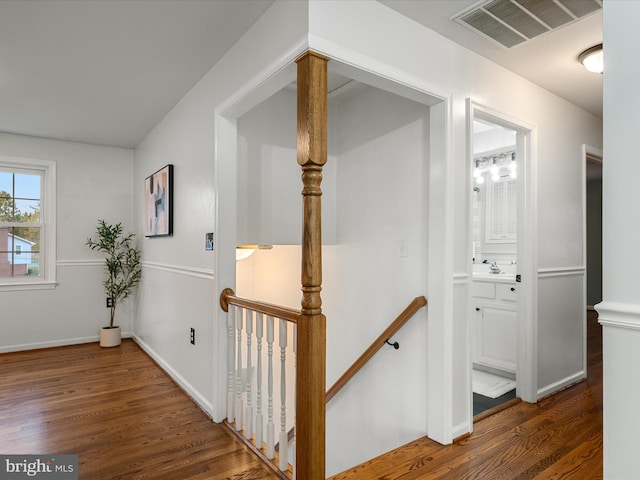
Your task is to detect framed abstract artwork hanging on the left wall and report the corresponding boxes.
[144,165,173,237]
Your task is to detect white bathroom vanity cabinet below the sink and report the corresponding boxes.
[471,280,518,373]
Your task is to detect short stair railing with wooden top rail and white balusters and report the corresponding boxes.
[220,288,301,480]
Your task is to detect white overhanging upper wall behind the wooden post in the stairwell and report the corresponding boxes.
[237,86,336,248]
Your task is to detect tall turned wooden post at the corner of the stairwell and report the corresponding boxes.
[296,52,329,480]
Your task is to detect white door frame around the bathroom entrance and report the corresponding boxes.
[467,98,538,408]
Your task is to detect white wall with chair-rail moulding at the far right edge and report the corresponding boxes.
[596,0,640,480]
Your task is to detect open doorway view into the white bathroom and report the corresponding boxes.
[470,115,518,417]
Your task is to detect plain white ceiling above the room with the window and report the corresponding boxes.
[0,0,272,147]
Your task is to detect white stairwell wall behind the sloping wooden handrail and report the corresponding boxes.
[323,87,429,475]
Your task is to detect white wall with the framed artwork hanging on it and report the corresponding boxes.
[134,2,307,421]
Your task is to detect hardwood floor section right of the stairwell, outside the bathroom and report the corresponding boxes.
[331,311,602,480]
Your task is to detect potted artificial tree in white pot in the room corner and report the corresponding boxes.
[86,220,142,347]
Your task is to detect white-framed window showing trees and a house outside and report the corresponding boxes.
[0,156,55,289]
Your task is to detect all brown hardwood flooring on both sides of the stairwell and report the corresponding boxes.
[0,312,602,480]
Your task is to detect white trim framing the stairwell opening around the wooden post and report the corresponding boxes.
[214,40,454,444]
